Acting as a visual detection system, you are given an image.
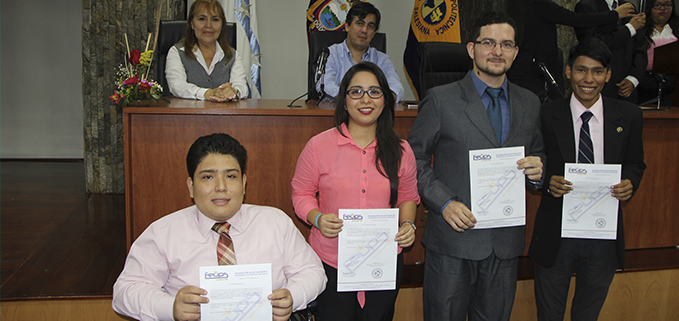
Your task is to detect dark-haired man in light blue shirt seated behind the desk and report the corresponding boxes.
[316,2,404,102]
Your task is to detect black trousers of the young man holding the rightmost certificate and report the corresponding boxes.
[535,238,618,321]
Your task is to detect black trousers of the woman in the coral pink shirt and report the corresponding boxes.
[315,253,403,321]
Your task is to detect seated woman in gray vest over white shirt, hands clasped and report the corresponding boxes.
[165,0,248,102]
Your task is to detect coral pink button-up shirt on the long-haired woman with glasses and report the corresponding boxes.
[292,124,420,268]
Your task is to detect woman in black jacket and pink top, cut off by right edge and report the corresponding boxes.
[638,0,679,106]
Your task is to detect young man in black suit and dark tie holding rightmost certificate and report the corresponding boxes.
[529,38,646,321]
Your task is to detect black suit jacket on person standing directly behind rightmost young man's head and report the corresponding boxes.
[575,0,650,101]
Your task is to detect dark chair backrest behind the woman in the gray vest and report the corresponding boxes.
[156,20,236,97]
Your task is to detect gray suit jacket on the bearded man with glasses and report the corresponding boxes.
[408,73,545,260]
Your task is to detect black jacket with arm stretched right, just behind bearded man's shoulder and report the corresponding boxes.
[507,0,618,99]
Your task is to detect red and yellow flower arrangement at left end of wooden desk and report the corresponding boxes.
[109,34,167,107]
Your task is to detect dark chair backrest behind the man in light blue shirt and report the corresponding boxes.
[307,30,387,99]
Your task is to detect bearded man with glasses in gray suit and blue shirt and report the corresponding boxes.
[408,12,544,321]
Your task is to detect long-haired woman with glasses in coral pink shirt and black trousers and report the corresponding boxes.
[292,62,420,321]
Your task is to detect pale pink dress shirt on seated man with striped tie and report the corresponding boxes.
[113,204,327,320]
